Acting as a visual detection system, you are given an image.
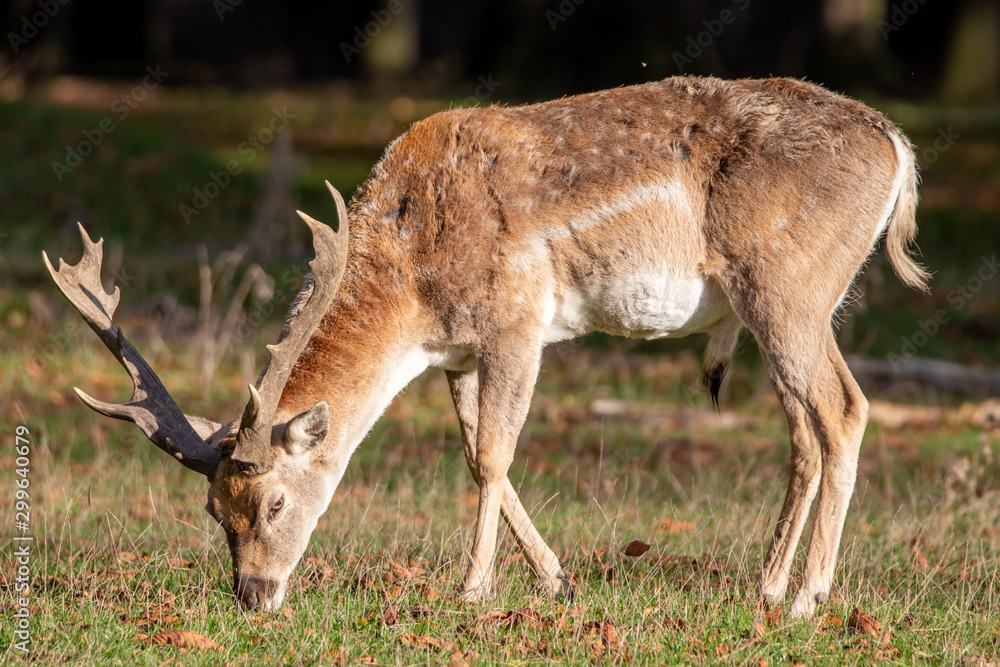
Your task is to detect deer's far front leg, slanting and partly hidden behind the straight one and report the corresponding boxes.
[446,371,572,597]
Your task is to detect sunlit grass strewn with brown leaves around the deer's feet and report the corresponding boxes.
[0,334,1000,665]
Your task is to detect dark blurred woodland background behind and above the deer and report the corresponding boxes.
[0,0,1000,395]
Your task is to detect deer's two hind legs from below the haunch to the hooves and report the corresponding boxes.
[758,322,868,616]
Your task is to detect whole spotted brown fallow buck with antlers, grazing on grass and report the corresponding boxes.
[45,77,927,616]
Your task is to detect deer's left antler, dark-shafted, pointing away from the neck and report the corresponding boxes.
[42,224,219,476]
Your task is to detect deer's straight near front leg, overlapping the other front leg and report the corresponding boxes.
[462,329,541,600]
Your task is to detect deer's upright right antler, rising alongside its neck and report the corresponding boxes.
[232,181,348,475]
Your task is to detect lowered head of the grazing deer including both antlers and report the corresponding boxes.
[42,183,348,609]
